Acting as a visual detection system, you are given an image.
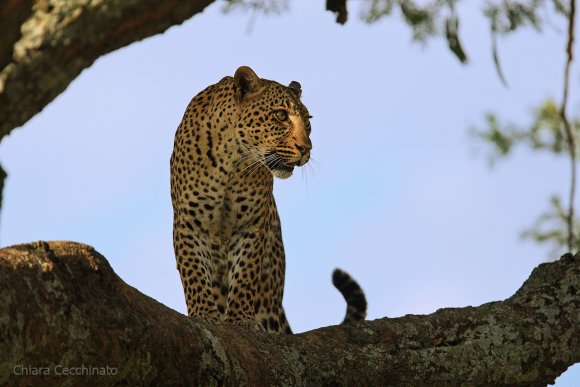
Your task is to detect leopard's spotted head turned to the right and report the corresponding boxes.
[234,66,312,179]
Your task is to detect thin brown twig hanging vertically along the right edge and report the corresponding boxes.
[560,0,576,251]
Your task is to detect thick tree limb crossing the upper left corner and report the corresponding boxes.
[0,0,214,140]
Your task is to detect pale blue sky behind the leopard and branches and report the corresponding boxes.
[0,1,580,386]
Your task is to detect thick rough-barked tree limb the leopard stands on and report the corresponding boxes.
[0,242,580,386]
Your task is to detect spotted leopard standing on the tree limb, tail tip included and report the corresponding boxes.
[170,66,367,334]
